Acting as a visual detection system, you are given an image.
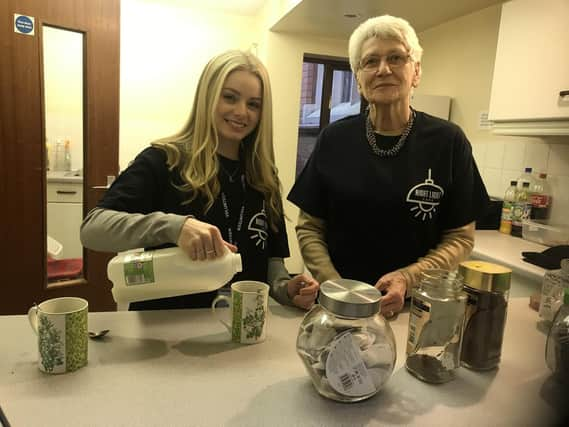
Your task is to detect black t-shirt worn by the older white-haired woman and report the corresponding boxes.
[288,112,489,285]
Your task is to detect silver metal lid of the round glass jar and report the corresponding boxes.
[318,279,381,317]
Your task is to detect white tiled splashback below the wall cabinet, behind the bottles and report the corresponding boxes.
[472,138,569,224]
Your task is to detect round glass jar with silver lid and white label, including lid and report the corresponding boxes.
[296,279,397,402]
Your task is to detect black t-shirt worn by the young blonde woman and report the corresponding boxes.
[98,147,289,310]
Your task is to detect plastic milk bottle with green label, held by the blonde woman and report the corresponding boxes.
[107,247,242,304]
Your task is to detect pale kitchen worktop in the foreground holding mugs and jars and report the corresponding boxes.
[0,298,566,427]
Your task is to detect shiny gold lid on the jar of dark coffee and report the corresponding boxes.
[458,261,512,292]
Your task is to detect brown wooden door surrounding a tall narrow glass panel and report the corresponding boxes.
[0,0,120,314]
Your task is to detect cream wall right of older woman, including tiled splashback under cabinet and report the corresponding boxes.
[417,5,569,223]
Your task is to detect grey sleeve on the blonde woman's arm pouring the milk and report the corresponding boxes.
[80,208,189,252]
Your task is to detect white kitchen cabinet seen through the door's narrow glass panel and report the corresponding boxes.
[47,179,83,259]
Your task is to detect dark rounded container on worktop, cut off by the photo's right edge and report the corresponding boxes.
[545,288,569,383]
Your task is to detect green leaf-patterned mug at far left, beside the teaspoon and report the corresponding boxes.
[28,297,89,374]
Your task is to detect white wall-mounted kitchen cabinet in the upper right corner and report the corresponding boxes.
[489,0,569,134]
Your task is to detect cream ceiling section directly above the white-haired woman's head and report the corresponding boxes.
[271,0,503,39]
